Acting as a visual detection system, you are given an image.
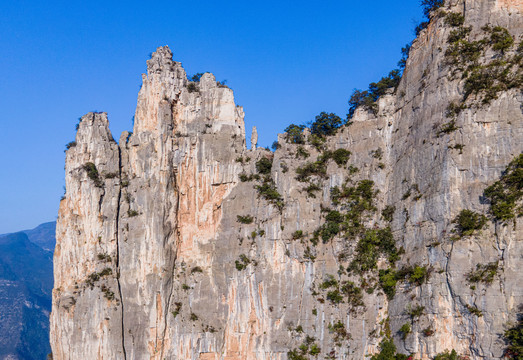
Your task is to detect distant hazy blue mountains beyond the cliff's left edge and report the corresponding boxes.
[0,222,55,360]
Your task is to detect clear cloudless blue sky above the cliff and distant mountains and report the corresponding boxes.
[0,0,422,233]
